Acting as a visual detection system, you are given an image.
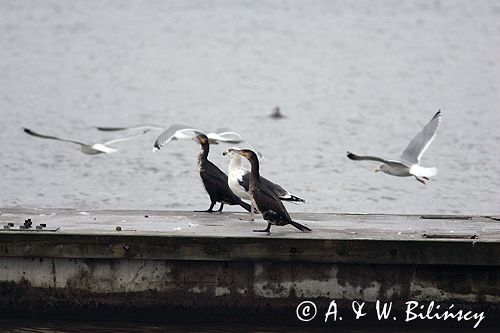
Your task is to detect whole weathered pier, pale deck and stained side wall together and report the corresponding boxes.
[0,209,500,327]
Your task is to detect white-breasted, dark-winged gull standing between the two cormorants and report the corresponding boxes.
[222,147,306,221]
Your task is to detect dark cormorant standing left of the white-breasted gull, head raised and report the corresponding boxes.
[196,133,251,213]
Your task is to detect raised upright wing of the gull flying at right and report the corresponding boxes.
[401,110,441,165]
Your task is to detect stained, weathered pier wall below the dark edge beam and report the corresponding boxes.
[0,257,500,324]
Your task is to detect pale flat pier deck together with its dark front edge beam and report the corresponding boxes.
[0,209,500,265]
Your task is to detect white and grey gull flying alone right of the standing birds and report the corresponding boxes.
[347,110,441,184]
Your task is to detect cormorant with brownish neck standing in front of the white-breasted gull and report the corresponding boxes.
[234,149,312,233]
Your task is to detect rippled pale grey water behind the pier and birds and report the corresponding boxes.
[0,0,500,214]
